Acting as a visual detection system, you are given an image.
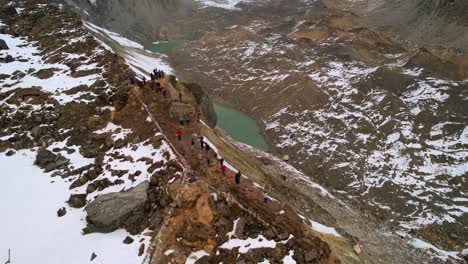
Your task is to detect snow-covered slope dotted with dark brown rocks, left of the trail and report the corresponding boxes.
[0,1,175,263]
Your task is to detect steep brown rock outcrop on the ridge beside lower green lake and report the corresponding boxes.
[184,83,218,128]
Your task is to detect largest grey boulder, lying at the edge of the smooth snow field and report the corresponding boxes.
[85,181,149,233]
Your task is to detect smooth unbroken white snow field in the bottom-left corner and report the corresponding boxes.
[0,151,150,264]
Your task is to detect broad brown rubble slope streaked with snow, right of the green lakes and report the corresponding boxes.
[172,1,468,254]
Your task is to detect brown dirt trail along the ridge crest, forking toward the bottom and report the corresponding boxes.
[130,75,338,263]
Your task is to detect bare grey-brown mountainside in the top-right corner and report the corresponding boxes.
[368,0,468,51]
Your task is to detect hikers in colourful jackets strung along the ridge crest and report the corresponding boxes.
[130,69,268,204]
